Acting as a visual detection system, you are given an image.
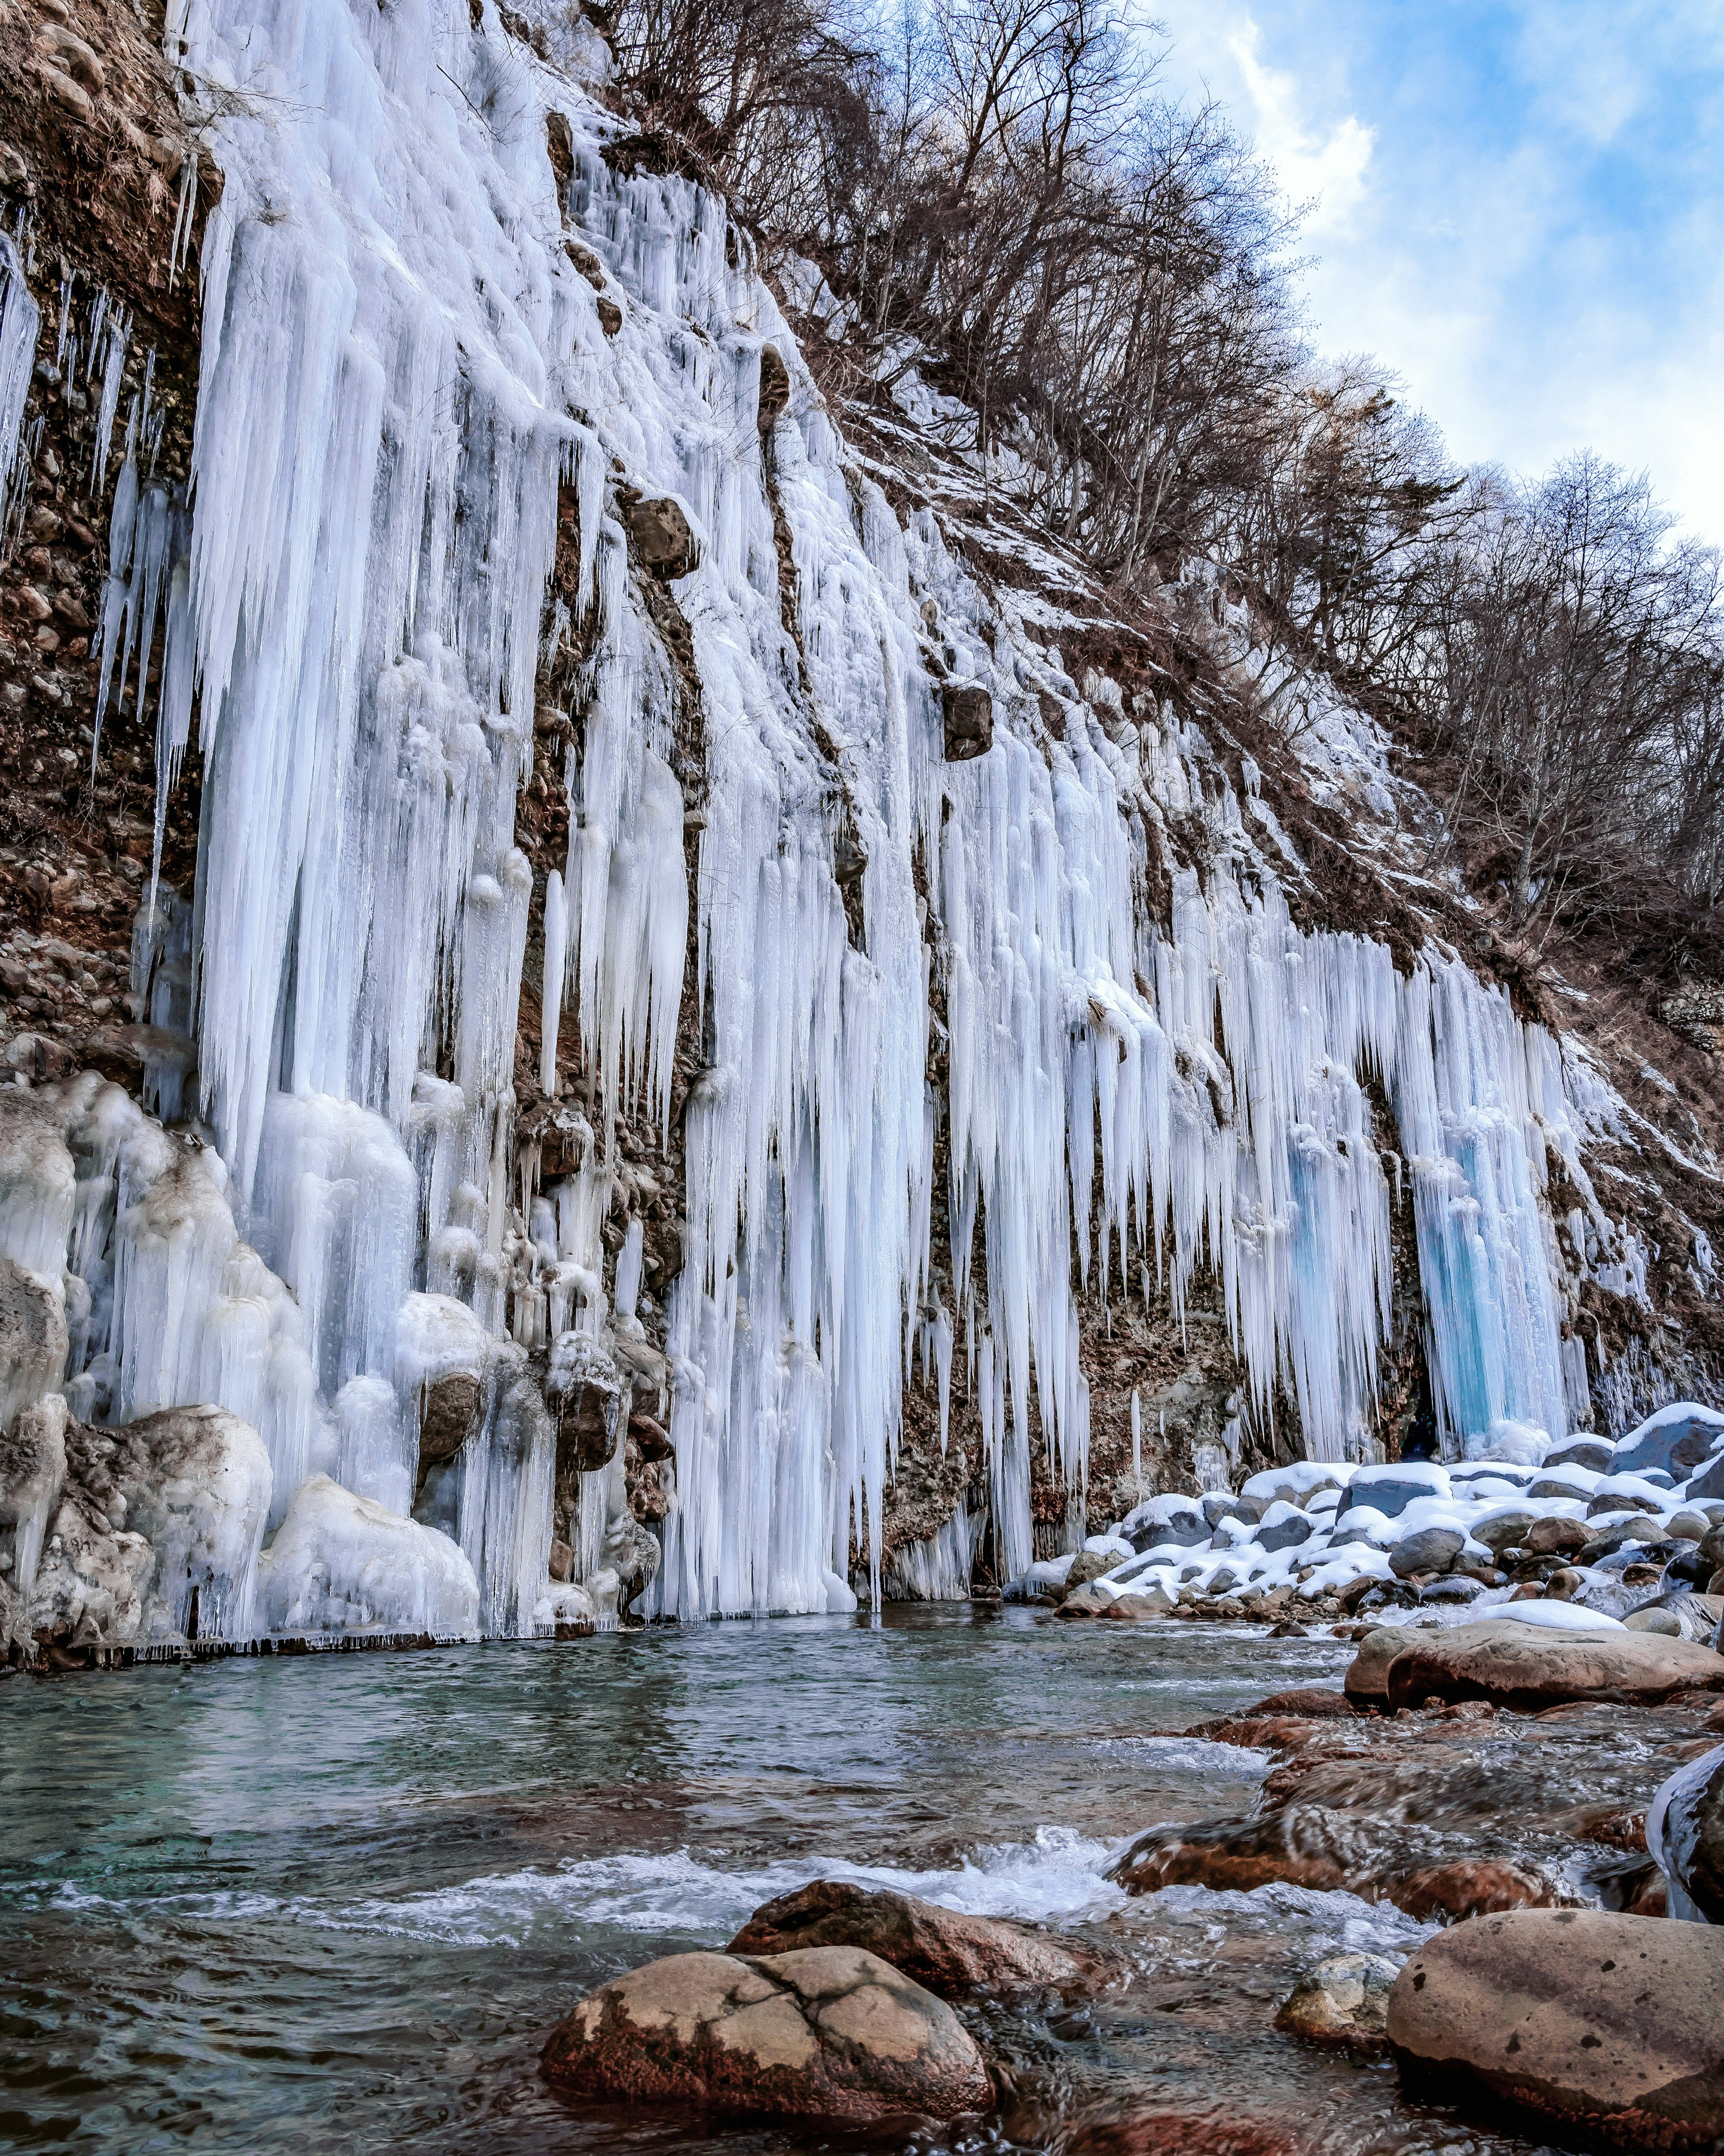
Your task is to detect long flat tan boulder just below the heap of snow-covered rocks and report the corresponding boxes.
[1379,1604,1724,1714]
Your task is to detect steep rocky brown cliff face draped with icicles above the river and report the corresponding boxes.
[0,0,1720,1639]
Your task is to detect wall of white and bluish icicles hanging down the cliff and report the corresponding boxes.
[0,0,1646,1632]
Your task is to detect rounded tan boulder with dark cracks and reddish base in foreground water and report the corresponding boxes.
[541,1947,991,2124]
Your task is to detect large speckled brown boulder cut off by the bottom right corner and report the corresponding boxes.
[1388,1908,1724,2152]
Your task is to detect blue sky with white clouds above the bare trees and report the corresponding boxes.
[1148,0,1724,546]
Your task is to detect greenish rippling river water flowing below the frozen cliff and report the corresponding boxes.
[0,1606,1560,2156]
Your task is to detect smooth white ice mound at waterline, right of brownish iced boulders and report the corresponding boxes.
[259,1475,479,1639]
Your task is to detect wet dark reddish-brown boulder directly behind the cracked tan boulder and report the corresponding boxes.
[724,1880,1084,1999]
